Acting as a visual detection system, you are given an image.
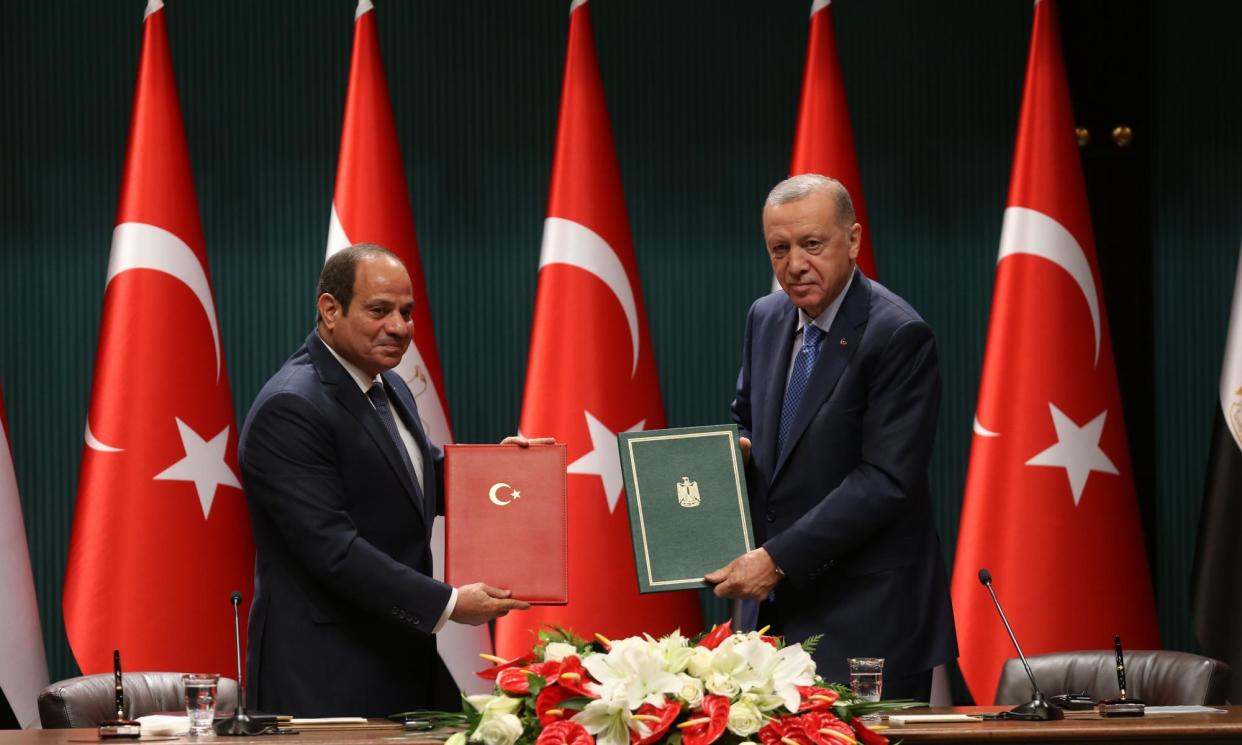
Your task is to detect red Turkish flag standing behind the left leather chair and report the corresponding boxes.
[63,0,255,673]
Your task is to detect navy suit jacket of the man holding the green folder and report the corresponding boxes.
[733,269,958,682]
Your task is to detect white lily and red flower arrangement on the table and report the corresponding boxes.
[440,623,915,745]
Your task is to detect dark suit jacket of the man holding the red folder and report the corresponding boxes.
[238,332,452,716]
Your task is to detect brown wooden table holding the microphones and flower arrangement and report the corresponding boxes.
[7,707,1242,745]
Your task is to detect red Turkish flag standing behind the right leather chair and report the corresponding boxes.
[953,0,1160,703]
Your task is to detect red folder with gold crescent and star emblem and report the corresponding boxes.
[445,445,569,605]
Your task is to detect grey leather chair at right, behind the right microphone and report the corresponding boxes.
[996,649,1232,707]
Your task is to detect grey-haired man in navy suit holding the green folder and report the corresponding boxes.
[707,174,958,700]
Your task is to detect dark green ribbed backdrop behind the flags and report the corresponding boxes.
[0,0,1242,679]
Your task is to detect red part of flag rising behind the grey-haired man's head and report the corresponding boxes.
[789,0,877,277]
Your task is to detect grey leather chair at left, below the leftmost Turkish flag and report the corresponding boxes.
[39,673,237,729]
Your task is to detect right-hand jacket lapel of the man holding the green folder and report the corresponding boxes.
[773,269,871,479]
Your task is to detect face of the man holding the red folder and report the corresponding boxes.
[319,256,414,375]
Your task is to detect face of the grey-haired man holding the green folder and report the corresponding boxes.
[764,191,862,318]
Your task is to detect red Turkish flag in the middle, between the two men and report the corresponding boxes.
[496,0,703,657]
